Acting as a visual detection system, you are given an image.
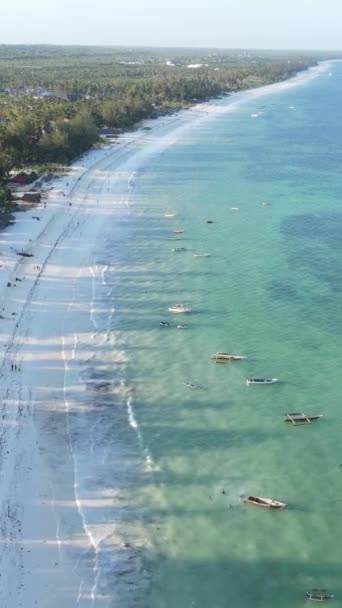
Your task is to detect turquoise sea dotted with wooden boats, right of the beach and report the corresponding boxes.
[97,63,342,608]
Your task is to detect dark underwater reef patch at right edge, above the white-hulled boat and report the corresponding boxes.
[266,212,342,334]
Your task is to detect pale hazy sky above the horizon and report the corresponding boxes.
[0,0,342,50]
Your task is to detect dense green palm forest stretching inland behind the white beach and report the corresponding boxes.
[0,45,336,183]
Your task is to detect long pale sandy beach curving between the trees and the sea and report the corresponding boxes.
[0,59,327,608]
